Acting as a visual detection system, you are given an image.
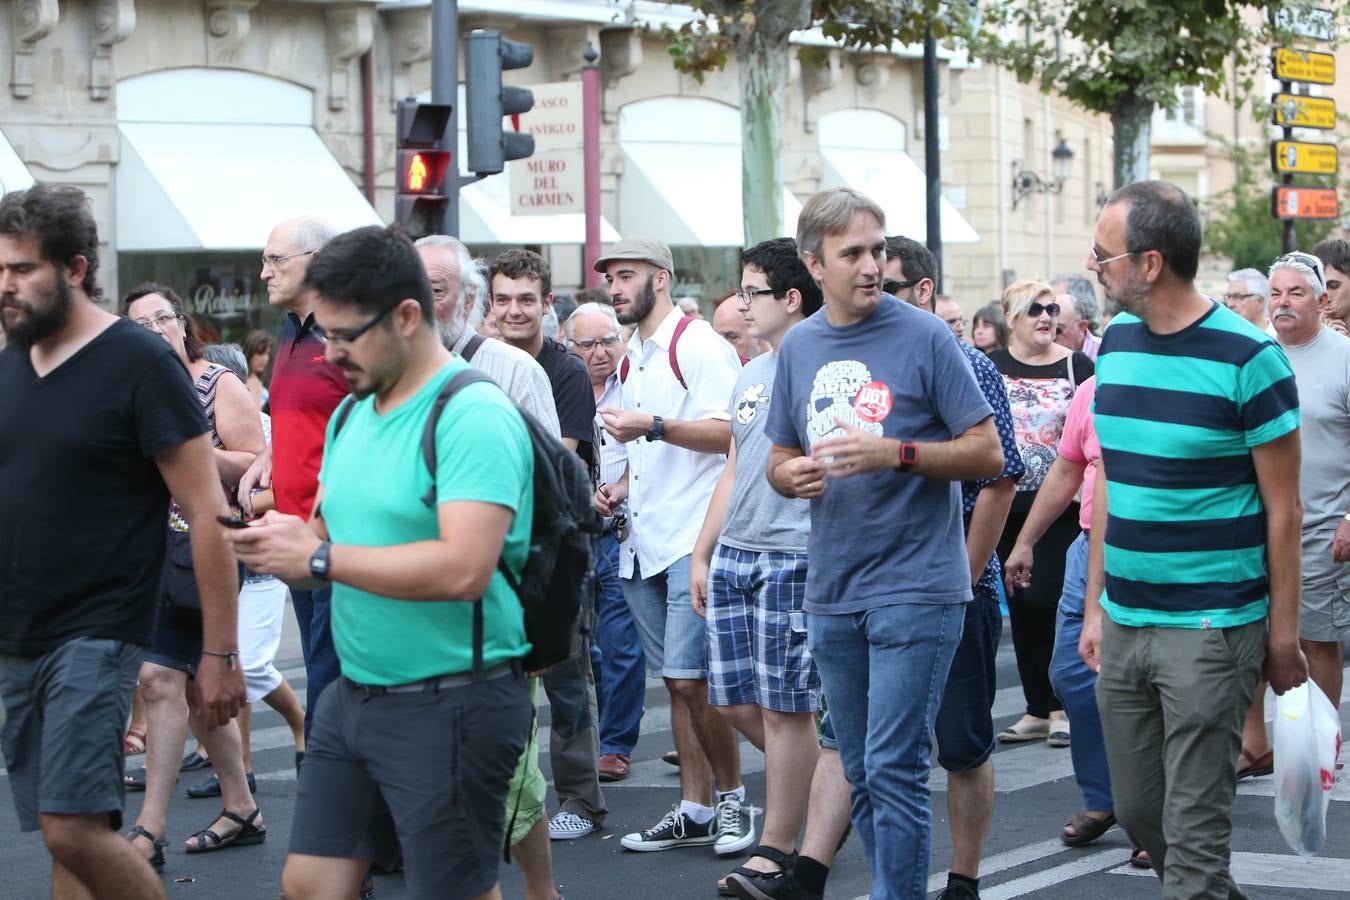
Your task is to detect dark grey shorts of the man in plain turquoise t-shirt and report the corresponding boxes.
[290,669,533,900]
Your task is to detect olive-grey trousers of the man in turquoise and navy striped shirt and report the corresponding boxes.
[1096,615,1266,900]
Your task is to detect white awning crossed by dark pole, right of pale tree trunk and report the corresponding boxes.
[821,146,980,244]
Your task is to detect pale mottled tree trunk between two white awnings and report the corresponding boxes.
[736,32,795,247]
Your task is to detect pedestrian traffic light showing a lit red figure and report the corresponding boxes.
[394,100,458,239]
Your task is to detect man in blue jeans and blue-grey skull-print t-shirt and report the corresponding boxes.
[767,188,1003,897]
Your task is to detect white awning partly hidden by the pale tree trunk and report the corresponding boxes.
[618,140,802,247]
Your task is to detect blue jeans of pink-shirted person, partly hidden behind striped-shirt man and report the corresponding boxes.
[1050,532,1115,812]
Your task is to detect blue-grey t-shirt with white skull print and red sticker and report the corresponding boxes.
[767,294,994,614]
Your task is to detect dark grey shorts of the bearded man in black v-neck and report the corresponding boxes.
[0,638,144,831]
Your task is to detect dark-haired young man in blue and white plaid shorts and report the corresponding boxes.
[690,237,821,896]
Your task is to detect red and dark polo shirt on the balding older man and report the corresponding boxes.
[267,313,351,518]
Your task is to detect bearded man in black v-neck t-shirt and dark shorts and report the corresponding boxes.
[0,185,244,899]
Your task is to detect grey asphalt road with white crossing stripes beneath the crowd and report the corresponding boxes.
[0,601,1350,900]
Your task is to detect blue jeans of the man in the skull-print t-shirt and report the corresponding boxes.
[806,603,965,900]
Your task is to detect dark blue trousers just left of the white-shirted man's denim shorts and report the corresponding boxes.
[591,533,647,756]
